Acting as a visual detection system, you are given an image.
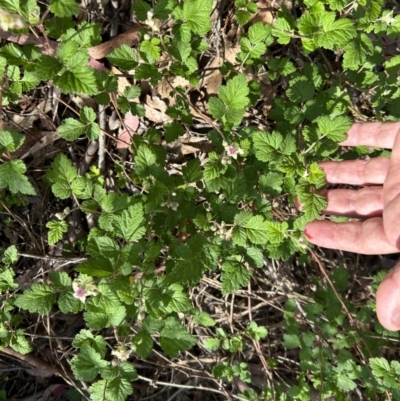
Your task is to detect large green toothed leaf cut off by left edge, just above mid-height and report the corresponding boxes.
[0,160,36,195]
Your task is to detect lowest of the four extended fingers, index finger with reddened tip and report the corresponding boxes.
[304,217,399,255]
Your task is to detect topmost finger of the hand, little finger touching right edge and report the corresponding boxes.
[340,122,400,149]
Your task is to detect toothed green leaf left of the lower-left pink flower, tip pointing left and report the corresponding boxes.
[15,283,56,315]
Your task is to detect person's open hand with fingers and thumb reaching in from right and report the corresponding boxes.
[304,122,400,331]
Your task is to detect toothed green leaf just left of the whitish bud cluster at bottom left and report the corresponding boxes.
[71,345,108,381]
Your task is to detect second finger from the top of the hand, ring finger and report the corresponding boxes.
[318,157,390,185]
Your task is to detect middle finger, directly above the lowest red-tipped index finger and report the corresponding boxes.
[323,187,383,217]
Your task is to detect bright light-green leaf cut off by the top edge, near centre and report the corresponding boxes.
[183,0,213,35]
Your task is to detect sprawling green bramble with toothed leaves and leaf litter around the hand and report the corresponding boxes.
[0,0,400,401]
